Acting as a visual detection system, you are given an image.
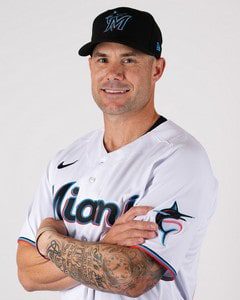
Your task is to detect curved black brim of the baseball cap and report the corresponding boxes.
[78,38,160,57]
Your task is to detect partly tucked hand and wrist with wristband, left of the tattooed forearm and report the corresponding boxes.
[37,218,68,257]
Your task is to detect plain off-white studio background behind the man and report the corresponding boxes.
[0,0,240,300]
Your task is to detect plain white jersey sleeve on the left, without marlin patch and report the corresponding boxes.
[18,164,54,246]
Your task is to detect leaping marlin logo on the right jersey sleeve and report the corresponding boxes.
[155,201,193,246]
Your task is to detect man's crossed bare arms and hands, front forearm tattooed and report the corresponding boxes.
[18,207,164,297]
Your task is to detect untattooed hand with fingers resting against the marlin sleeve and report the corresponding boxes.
[100,206,158,246]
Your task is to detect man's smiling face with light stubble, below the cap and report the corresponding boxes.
[89,42,165,115]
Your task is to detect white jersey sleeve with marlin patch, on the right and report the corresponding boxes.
[134,141,218,280]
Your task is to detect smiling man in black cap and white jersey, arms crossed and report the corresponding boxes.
[17,7,217,300]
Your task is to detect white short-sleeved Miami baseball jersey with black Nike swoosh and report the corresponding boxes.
[19,120,218,300]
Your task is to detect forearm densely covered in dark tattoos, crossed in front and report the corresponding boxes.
[47,236,162,296]
